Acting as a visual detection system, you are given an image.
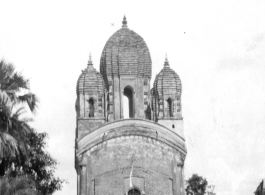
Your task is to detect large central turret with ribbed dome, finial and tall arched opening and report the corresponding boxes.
[100,16,152,121]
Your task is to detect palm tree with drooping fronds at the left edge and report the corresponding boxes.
[0,60,38,164]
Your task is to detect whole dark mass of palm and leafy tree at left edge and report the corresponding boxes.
[0,61,65,195]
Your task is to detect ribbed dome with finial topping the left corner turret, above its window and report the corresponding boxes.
[77,56,105,94]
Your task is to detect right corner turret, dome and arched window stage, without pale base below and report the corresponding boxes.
[153,57,181,119]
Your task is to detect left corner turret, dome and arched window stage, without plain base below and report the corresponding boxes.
[77,56,105,119]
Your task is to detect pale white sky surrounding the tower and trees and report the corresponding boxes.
[0,0,265,195]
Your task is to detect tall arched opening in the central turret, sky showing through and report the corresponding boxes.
[123,87,134,119]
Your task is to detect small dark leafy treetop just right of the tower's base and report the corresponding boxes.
[185,174,208,195]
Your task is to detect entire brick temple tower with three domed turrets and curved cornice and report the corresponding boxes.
[75,17,187,195]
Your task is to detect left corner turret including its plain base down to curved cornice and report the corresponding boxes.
[76,55,105,138]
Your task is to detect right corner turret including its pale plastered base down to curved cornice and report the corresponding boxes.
[153,56,184,138]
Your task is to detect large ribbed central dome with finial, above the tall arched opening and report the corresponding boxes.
[100,17,152,80]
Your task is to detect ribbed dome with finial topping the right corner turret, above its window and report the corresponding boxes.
[153,57,182,95]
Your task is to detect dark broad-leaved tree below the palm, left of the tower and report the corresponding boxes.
[5,131,65,195]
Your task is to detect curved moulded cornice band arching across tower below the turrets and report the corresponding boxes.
[77,119,186,156]
